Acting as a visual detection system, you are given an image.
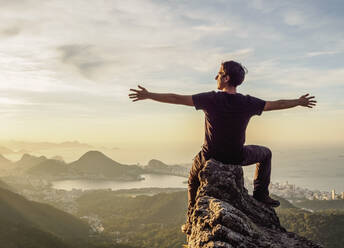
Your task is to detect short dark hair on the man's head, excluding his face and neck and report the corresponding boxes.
[222,60,248,87]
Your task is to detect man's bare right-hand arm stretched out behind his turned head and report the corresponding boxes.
[264,94,317,111]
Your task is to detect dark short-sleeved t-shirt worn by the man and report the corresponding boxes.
[192,91,266,164]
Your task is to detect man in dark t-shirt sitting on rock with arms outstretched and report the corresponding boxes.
[129,61,316,211]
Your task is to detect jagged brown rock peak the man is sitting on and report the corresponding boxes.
[183,159,322,248]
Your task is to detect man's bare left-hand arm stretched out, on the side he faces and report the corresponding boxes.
[129,85,194,106]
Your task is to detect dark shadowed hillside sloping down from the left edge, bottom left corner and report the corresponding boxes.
[0,188,89,247]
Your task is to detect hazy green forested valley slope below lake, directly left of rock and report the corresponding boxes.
[78,191,187,248]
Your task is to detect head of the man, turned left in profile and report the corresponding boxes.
[215,60,247,90]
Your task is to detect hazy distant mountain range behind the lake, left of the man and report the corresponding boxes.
[0,151,188,181]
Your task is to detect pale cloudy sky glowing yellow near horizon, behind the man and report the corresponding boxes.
[0,0,344,163]
